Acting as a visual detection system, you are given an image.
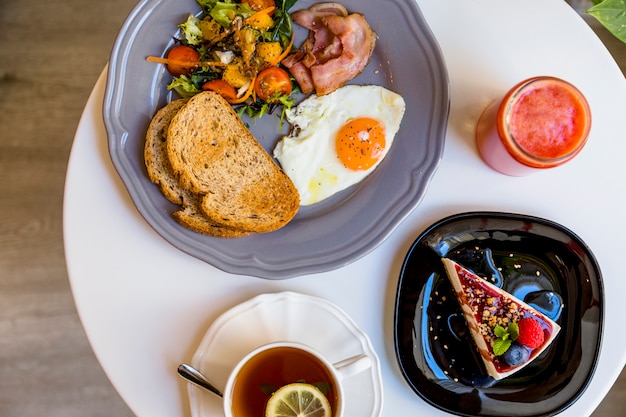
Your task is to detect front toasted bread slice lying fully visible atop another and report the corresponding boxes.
[167,91,300,233]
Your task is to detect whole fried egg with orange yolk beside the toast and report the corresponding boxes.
[274,85,405,206]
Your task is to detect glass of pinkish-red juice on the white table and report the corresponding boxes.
[476,76,591,176]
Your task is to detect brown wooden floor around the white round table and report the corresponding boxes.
[0,0,626,417]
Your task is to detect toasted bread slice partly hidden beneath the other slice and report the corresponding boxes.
[144,99,250,238]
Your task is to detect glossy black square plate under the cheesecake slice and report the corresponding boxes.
[395,212,603,417]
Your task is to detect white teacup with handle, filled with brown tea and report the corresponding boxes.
[224,342,372,417]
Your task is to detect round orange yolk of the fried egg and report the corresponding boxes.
[335,117,385,171]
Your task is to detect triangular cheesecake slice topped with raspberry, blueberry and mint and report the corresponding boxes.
[442,258,561,380]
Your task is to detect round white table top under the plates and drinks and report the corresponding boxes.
[64,0,626,417]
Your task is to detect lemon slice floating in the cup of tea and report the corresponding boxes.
[265,383,332,417]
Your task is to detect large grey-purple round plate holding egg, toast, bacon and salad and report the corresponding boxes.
[103,0,449,279]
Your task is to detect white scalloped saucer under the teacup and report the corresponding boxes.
[188,292,383,417]
